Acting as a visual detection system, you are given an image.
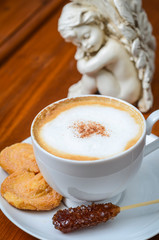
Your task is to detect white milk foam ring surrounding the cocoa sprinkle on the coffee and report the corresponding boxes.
[40,104,139,159]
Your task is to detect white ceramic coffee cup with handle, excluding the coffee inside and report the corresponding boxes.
[31,95,159,206]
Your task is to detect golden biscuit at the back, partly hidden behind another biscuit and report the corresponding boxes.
[0,143,40,174]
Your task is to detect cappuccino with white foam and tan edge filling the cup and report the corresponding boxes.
[33,96,144,160]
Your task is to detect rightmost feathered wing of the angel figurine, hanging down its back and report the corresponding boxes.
[114,0,156,112]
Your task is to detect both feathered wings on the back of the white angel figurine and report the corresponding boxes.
[72,0,156,112]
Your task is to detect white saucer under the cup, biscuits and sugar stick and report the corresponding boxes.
[0,135,159,240]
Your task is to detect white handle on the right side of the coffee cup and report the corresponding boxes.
[144,110,159,156]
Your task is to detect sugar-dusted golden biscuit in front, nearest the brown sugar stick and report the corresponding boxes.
[1,170,62,211]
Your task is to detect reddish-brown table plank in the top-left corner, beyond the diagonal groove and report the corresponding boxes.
[0,0,66,64]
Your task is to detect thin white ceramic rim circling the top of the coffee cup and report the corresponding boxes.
[31,94,146,165]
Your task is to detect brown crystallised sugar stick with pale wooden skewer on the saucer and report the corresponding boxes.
[53,199,159,233]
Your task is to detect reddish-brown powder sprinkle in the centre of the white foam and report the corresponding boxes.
[70,121,110,138]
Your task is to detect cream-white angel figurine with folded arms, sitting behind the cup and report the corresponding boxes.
[58,0,156,112]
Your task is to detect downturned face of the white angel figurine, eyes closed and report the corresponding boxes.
[73,24,104,53]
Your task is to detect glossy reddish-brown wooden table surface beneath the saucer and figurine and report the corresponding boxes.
[0,0,159,240]
